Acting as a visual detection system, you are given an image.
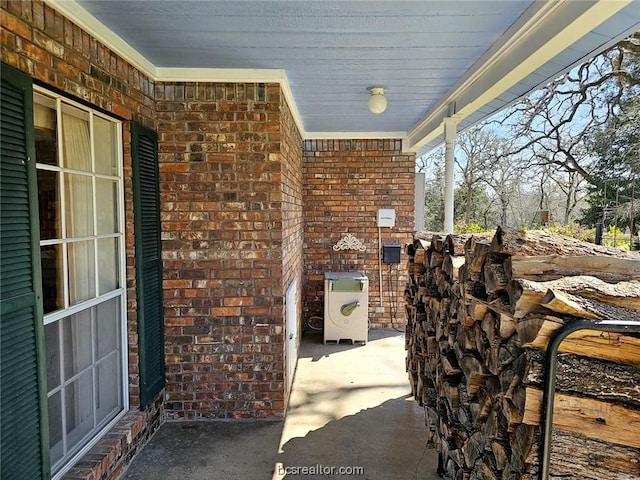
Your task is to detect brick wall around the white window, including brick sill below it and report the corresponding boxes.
[0,0,163,478]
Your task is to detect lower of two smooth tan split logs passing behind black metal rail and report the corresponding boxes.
[522,387,640,448]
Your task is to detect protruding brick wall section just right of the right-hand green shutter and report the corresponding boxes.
[156,83,301,418]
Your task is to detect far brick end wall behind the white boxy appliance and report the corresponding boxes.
[303,140,415,328]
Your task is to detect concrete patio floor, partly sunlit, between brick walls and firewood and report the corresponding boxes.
[121,330,440,480]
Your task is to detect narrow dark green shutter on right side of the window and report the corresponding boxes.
[131,123,165,408]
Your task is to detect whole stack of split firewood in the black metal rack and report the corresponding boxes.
[405,227,640,480]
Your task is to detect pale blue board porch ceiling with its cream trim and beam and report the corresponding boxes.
[48,0,640,152]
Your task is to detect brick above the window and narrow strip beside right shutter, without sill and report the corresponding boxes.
[2,1,155,406]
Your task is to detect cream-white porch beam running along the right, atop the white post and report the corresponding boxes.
[407,0,633,151]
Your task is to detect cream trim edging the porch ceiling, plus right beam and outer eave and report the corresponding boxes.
[46,0,640,153]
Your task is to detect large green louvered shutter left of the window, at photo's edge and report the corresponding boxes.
[0,64,49,480]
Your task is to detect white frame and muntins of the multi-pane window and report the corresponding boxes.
[33,85,129,480]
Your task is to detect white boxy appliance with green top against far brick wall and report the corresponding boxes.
[324,272,369,343]
